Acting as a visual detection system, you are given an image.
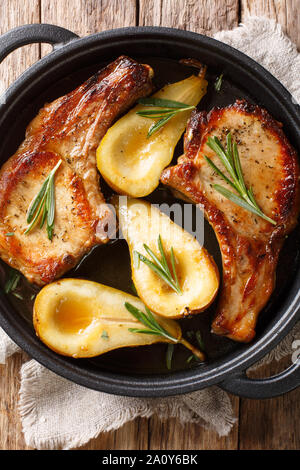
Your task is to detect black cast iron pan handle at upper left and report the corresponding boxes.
[0,23,78,62]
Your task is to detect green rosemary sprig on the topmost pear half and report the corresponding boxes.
[136,98,195,138]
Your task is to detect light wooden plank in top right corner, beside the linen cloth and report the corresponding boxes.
[241,0,300,49]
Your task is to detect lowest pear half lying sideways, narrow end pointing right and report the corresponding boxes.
[33,279,181,358]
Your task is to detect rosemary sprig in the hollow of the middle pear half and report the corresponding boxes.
[133,235,182,294]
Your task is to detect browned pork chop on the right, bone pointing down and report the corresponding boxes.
[161,101,299,342]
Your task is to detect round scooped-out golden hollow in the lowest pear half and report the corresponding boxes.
[53,297,96,334]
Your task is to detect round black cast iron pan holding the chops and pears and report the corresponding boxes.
[0,24,300,398]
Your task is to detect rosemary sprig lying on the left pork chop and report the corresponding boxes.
[24,160,62,240]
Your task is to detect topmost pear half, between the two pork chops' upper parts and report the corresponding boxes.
[97,68,207,197]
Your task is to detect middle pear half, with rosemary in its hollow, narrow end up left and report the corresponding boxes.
[113,196,219,318]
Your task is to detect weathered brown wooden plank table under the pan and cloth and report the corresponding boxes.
[0,0,300,450]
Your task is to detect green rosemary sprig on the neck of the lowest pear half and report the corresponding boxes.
[124,302,205,361]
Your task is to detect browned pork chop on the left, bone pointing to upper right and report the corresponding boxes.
[0,57,153,285]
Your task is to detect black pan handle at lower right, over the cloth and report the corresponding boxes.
[218,354,300,399]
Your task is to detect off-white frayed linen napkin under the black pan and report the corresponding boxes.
[0,17,300,449]
